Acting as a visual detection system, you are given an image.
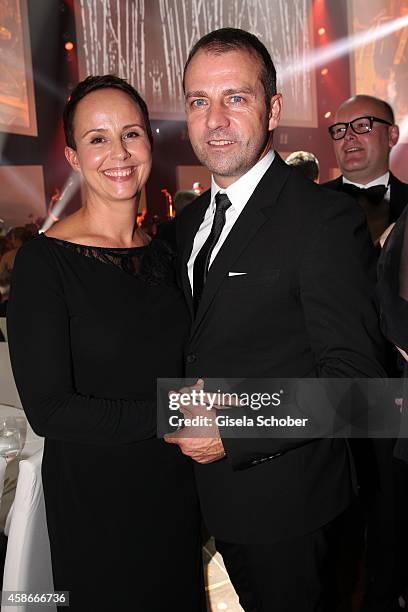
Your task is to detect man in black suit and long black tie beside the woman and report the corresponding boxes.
[167,28,384,612]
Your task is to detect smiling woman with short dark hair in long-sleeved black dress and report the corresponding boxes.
[8,75,205,612]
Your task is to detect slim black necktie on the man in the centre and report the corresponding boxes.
[193,193,231,312]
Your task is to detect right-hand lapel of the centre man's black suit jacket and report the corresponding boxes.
[190,154,291,335]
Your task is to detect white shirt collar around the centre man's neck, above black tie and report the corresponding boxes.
[210,149,275,213]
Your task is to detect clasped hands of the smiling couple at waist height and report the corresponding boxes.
[164,380,225,464]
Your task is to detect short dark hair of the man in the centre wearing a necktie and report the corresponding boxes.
[183,28,276,106]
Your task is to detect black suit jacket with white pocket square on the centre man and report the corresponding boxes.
[177,155,384,542]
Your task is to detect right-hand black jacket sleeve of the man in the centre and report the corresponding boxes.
[221,193,386,470]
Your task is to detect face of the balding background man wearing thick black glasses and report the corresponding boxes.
[333,99,398,185]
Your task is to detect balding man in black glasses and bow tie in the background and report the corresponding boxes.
[324,95,408,243]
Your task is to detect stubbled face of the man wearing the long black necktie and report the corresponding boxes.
[185,50,281,188]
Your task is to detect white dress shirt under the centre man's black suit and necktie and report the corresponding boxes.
[187,150,275,292]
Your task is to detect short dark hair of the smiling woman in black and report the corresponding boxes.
[63,74,153,149]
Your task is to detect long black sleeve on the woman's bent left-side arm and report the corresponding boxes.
[7,238,156,445]
